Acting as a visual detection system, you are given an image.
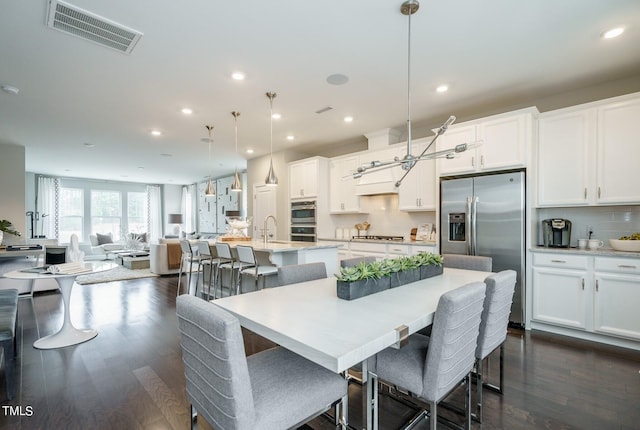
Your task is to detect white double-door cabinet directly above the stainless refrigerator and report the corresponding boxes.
[438,108,537,176]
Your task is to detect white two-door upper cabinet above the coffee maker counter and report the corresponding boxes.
[537,95,640,206]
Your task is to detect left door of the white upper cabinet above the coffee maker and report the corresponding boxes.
[537,109,596,206]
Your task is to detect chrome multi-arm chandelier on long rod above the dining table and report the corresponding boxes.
[345,0,476,187]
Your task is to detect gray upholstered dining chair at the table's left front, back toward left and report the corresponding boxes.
[176,295,347,430]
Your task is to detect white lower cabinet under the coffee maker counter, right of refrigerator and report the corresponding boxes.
[531,253,640,349]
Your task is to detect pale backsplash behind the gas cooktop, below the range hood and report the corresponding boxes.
[331,194,436,239]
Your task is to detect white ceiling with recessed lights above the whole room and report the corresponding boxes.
[0,0,640,184]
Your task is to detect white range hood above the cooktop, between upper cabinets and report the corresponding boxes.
[356,128,401,196]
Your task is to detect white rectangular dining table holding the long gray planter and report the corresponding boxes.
[212,268,491,430]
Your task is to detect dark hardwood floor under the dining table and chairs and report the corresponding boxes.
[0,277,640,430]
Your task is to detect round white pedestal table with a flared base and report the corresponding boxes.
[4,261,118,349]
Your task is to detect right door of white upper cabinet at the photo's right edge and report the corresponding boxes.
[596,99,640,204]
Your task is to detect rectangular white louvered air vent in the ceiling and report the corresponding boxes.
[47,0,142,54]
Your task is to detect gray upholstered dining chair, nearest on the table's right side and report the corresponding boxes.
[369,282,486,430]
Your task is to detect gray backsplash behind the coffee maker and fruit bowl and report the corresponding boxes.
[537,206,640,248]
